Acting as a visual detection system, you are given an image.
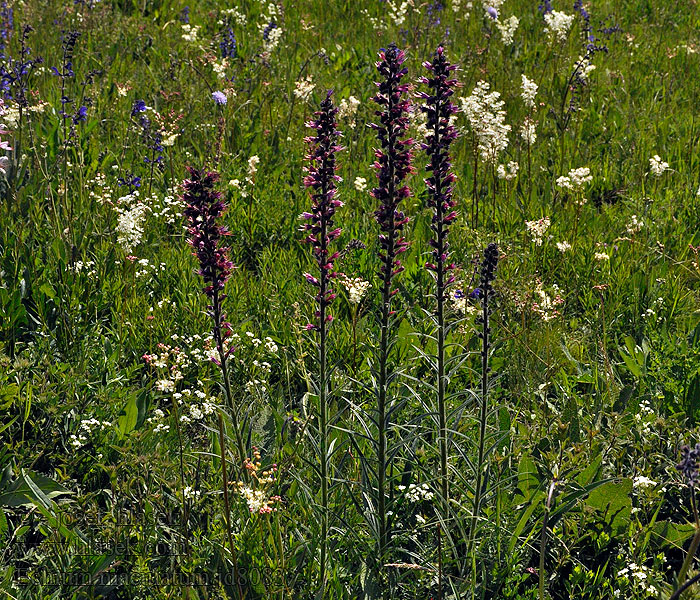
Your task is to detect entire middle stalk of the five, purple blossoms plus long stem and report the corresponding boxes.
[371,44,413,555]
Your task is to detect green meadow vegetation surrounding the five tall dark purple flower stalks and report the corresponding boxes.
[0,0,700,599]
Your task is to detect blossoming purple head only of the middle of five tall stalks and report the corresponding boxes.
[371,44,414,302]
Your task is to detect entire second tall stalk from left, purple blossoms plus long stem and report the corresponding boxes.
[301,91,343,596]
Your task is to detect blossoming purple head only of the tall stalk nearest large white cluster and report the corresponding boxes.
[419,46,457,304]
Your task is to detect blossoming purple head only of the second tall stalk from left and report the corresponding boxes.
[301,91,343,329]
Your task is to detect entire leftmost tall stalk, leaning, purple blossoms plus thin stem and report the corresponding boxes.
[182,167,246,597]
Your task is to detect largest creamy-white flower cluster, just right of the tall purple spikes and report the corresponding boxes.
[460,80,510,164]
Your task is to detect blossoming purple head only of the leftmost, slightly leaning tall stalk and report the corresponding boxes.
[182,167,234,302]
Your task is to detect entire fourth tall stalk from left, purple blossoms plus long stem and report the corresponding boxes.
[419,46,457,502]
